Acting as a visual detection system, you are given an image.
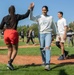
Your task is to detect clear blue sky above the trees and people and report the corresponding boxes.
[0,0,74,25]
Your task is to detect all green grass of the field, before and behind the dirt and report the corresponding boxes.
[0,40,74,75]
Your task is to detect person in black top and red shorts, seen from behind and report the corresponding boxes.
[0,4,31,70]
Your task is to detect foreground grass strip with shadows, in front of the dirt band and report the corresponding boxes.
[0,65,74,75]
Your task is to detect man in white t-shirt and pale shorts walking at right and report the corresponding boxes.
[56,11,68,60]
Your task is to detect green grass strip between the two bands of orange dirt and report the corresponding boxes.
[0,46,74,56]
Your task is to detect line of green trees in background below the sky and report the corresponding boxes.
[17,22,74,37]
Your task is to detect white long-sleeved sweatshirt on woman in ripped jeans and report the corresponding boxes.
[30,11,56,33]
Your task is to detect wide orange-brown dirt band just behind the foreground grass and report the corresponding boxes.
[0,55,74,65]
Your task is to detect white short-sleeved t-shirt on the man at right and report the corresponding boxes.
[57,18,68,34]
